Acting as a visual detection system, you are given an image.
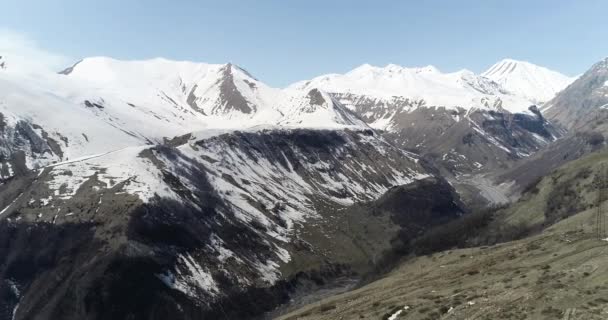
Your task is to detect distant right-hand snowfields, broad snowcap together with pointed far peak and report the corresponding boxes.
[290,60,572,113]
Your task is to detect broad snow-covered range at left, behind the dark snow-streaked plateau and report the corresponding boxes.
[0,58,368,172]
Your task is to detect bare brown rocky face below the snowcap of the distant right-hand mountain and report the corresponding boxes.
[337,95,563,176]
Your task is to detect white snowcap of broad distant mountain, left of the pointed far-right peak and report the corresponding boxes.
[290,64,529,111]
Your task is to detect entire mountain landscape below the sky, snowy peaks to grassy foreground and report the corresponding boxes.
[0,51,608,320]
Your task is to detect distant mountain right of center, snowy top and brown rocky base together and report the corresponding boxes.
[290,60,567,176]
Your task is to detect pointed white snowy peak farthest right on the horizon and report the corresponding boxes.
[481,59,576,105]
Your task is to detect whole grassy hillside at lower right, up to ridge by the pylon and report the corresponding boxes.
[280,152,608,320]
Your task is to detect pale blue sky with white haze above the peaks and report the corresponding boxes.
[0,0,608,87]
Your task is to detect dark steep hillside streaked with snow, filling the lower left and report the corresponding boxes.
[0,114,463,319]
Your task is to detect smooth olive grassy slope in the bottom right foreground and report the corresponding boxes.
[278,222,608,320]
